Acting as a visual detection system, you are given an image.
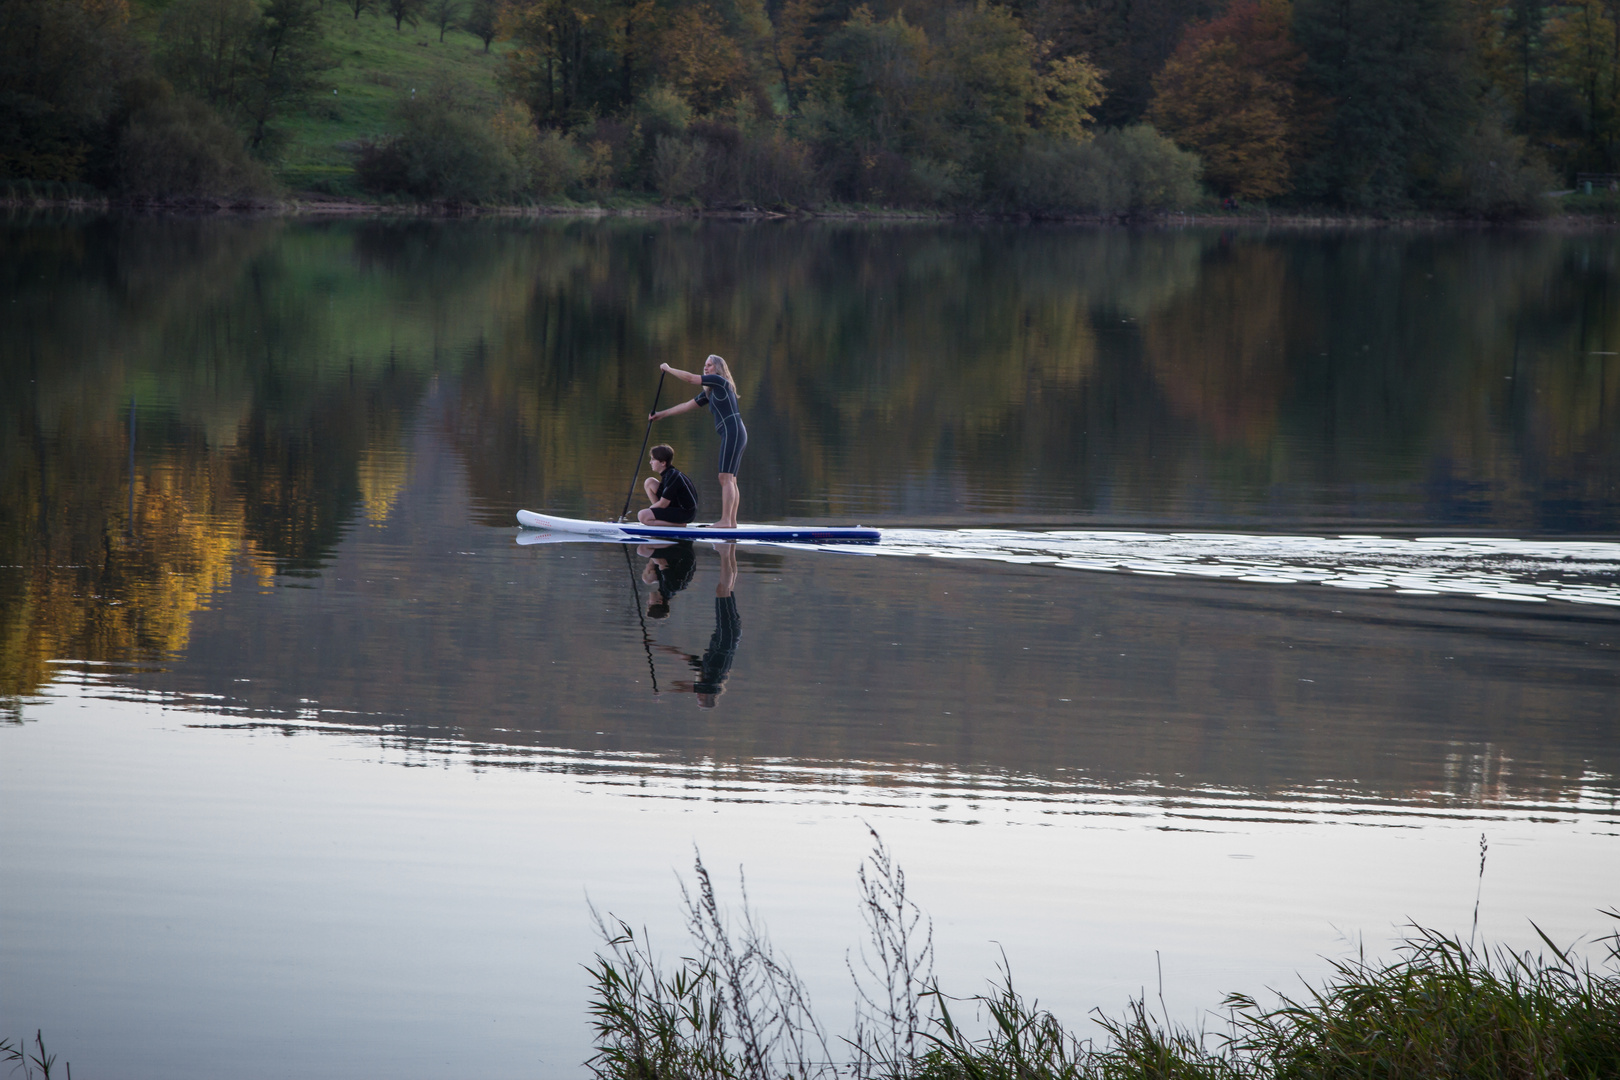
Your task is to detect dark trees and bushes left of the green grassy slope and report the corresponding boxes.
[0,0,321,198]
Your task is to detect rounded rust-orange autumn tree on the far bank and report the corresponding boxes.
[1147,0,1304,199]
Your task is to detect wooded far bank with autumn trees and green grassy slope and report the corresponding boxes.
[15,0,1620,223]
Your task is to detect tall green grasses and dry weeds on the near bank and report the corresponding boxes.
[586,832,1620,1080]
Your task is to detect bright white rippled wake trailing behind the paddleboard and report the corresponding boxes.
[782,529,1620,607]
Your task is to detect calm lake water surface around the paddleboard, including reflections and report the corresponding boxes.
[0,219,1620,1078]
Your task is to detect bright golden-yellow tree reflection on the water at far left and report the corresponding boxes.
[0,381,416,698]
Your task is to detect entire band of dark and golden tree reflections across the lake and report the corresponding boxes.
[0,219,1620,709]
